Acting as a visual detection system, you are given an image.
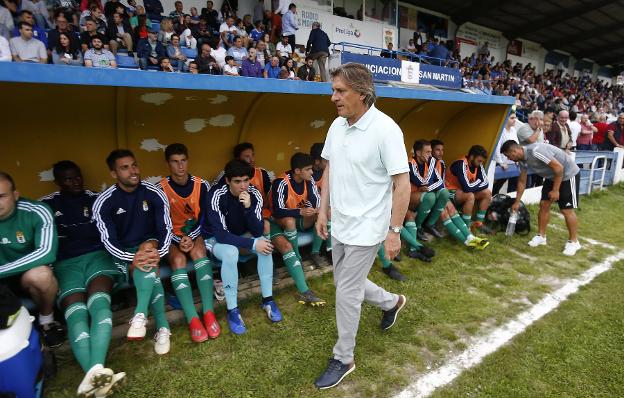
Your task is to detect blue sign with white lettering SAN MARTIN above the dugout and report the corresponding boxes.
[340,52,462,89]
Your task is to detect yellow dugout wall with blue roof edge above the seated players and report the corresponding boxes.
[0,63,513,198]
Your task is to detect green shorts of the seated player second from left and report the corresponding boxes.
[54,250,122,300]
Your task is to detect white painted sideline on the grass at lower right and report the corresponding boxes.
[397,247,624,398]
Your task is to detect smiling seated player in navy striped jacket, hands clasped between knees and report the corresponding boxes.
[93,149,171,355]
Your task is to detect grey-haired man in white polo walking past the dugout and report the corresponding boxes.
[314,63,410,389]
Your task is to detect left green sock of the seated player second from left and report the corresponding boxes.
[65,303,91,373]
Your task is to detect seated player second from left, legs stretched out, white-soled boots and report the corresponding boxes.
[41,160,126,397]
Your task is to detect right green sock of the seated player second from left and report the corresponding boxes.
[87,292,113,366]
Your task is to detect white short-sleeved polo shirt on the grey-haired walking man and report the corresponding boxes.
[321,106,409,246]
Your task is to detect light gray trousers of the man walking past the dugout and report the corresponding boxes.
[332,236,399,364]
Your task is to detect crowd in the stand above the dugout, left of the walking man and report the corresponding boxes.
[0,0,331,81]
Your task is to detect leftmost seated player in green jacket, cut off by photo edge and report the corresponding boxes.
[0,172,64,347]
